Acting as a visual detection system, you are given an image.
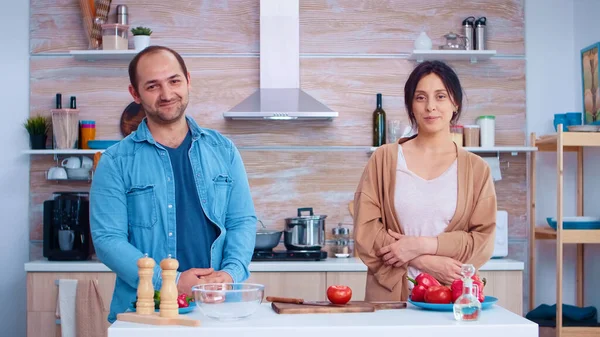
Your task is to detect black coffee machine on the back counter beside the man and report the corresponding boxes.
[43,192,91,261]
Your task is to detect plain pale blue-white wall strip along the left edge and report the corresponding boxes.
[0,1,29,337]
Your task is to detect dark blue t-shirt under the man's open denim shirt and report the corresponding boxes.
[163,131,218,272]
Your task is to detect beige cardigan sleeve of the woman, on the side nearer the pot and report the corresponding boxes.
[354,162,408,291]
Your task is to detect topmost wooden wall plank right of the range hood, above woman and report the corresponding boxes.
[300,0,525,55]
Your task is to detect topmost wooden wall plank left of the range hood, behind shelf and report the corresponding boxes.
[30,0,259,53]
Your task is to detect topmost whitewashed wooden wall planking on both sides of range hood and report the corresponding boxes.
[30,0,525,55]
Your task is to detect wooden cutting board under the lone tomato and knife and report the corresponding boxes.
[271,301,406,314]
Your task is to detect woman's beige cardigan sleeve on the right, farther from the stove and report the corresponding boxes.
[436,166,497,269]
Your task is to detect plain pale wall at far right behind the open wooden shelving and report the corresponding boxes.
[525,0,600,307]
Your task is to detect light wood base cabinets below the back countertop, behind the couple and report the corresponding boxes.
[27,260,523,337]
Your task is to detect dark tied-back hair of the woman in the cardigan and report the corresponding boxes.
[404,61,463,129]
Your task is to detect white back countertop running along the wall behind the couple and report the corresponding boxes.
[25,257,524,272]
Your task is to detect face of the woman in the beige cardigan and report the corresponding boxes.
[412,73,457,134]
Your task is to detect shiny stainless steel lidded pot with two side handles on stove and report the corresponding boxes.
[283,207,327,250]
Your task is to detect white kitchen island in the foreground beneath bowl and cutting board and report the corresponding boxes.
[108,303,538,337]
